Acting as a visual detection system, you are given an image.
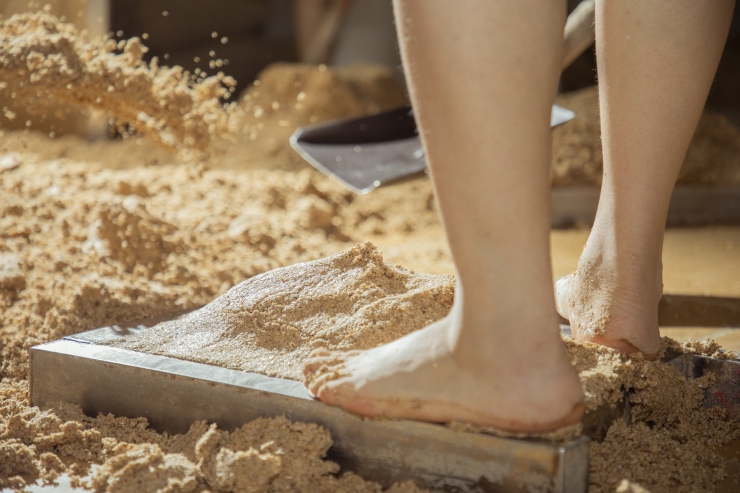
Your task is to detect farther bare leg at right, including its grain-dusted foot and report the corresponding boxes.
[557,0,734,357]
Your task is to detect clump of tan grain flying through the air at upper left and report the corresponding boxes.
[0,12,235,152]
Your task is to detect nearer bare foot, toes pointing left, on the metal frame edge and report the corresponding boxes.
[304,296,584,433]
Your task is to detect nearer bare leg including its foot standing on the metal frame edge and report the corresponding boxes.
[304,0,583,431]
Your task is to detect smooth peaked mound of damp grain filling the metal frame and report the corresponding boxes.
[110,243,454,380]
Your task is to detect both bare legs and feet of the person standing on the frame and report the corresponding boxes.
[304,0,733,432]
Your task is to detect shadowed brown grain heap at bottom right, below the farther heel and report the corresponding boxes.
[568,339,740,493]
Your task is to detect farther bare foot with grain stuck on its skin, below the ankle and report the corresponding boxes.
[555,247,663,359]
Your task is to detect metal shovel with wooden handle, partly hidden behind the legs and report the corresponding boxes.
[290,0,594,194]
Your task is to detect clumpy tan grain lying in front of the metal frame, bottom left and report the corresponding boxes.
[0,380,420,493]
